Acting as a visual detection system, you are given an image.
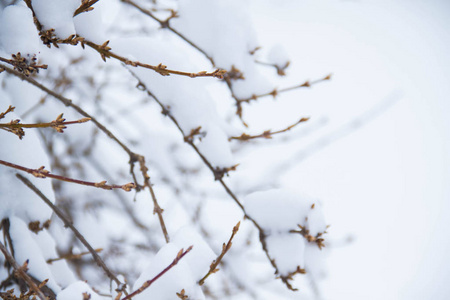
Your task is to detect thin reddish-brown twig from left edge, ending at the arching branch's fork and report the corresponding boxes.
[0,160,135,192]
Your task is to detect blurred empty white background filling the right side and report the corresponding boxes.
[250,0,450,299]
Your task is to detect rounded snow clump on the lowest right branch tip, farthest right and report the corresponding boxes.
[244,189,326,275]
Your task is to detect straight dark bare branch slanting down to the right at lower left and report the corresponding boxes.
[16,174,126,293]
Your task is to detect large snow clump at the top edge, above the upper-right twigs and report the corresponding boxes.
[173,0,273,99]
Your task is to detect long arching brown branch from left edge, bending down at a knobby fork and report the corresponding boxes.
[0,64,169,243]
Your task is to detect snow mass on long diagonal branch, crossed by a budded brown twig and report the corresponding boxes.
[110,32,235,168]
